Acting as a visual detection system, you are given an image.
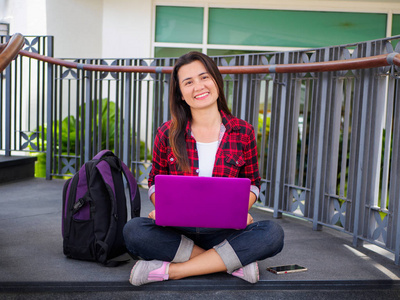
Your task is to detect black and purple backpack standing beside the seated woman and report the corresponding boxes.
[62,150,140,266]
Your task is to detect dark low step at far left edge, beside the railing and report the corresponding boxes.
[0,155,37,183]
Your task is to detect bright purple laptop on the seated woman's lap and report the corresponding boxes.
[155,175,250,229]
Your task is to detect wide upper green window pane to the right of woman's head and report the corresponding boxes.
[208,8,387,48]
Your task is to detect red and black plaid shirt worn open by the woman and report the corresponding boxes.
[148,111,261,194]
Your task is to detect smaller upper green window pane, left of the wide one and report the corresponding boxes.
[155,6,204,44]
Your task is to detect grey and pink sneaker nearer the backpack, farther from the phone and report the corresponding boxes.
[129,260,170,286]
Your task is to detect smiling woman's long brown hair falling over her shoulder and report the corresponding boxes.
[169,51,231,172]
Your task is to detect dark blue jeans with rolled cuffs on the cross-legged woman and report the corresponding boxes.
[124,218,284,273]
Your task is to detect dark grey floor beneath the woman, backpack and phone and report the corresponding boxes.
[0,178,400,299]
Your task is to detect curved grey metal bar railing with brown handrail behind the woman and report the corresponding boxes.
[0,36,400,264]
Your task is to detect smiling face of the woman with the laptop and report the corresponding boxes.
[178,60,218,110]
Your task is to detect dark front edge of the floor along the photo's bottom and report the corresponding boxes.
[0,278,400,300]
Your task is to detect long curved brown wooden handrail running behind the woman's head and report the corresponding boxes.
[0,34,400,74]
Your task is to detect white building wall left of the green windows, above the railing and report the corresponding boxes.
[0,0,153,58]
